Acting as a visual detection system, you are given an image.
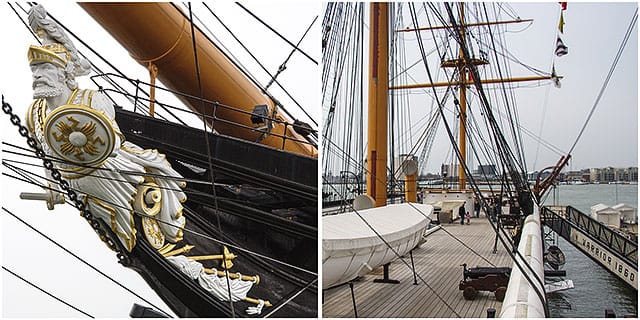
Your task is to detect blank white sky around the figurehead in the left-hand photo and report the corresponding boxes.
[0,1,322,318]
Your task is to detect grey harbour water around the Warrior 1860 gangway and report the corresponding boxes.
[546,184,638,318]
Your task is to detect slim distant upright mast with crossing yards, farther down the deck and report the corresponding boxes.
[458,2,467,190]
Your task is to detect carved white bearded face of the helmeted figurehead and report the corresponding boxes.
[31,62,65,99]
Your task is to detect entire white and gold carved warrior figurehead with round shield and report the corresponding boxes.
[21,5,271,314]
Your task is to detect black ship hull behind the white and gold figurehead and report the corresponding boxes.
[116,110,317,318]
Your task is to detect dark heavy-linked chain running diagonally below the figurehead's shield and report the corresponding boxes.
[2,95,130,266]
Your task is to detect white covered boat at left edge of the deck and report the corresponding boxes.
[322,203,433,288]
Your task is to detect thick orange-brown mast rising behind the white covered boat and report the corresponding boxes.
[367,2,389,207]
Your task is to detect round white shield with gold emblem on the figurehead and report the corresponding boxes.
[44,105,115,166]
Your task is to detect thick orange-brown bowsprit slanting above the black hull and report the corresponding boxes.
[79,2,318,157]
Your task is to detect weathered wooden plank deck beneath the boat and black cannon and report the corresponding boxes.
[322,214,512,318]
